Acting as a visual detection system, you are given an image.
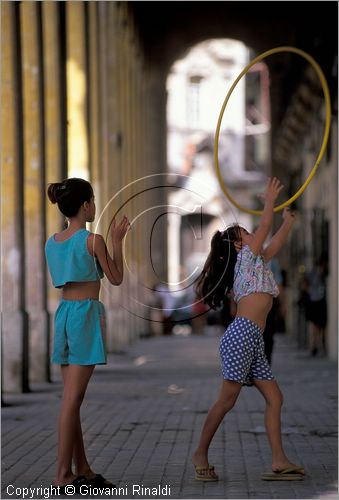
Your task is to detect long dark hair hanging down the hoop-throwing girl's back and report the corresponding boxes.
[196,224,241,309]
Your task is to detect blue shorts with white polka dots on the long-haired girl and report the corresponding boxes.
[220,317,274,385]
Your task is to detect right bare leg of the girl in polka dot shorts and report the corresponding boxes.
[254,380,304,472]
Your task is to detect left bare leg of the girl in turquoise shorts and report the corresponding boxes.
[54,365,94,486]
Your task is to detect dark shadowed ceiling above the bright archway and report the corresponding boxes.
[129,1,338,73]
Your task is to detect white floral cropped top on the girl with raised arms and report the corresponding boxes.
[233,245,279,302]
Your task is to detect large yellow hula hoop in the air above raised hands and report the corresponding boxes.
[214,47,331,215]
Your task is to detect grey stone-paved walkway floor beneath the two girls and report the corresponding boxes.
[1,332,338,499]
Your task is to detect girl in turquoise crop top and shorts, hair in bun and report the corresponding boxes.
[45,178,130,493]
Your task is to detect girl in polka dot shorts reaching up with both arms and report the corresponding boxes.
[192,178,304,481]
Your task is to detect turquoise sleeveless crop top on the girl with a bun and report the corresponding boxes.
[45,229,104,288]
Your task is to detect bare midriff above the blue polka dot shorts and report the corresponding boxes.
[236,293,273,330]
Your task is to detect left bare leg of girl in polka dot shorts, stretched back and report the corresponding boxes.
[192,380,242,467]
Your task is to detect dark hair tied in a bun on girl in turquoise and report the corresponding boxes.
[47,177,93,217]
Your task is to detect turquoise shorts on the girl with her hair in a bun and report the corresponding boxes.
[52,299,107,365]
